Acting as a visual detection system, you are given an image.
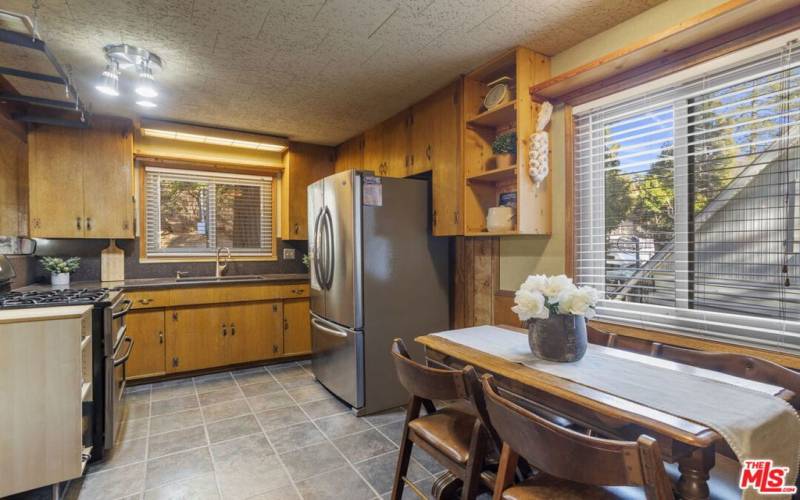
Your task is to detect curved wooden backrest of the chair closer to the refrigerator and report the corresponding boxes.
[392,339,468,400]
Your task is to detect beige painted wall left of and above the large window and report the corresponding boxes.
[500,0,725,290]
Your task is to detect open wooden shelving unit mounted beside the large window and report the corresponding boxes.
[463,47,551,236]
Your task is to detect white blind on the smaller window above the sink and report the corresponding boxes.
[145,167,273,256]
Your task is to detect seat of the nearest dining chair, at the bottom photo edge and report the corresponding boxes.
[502,474,645,500]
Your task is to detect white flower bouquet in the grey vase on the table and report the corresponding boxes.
[511,274,600,321]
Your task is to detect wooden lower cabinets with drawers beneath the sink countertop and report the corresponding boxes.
[126,292,311,379]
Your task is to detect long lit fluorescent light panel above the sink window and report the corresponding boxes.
[140,121,287,153]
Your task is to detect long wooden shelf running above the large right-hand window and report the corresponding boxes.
[530,0,787,103]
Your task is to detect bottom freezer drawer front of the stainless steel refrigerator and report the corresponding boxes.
[311,314,364,408]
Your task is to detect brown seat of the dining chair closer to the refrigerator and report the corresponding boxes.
[408,401,476,464]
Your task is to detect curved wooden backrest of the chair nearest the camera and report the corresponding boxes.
[483,375,672,500]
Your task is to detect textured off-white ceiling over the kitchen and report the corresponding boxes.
[0,0,661,144]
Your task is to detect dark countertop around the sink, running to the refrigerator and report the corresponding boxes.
[14,274,309,292]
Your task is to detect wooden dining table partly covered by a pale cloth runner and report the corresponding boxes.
[416,326,794,499]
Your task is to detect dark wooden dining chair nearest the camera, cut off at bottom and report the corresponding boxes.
[482,375,673,500]
